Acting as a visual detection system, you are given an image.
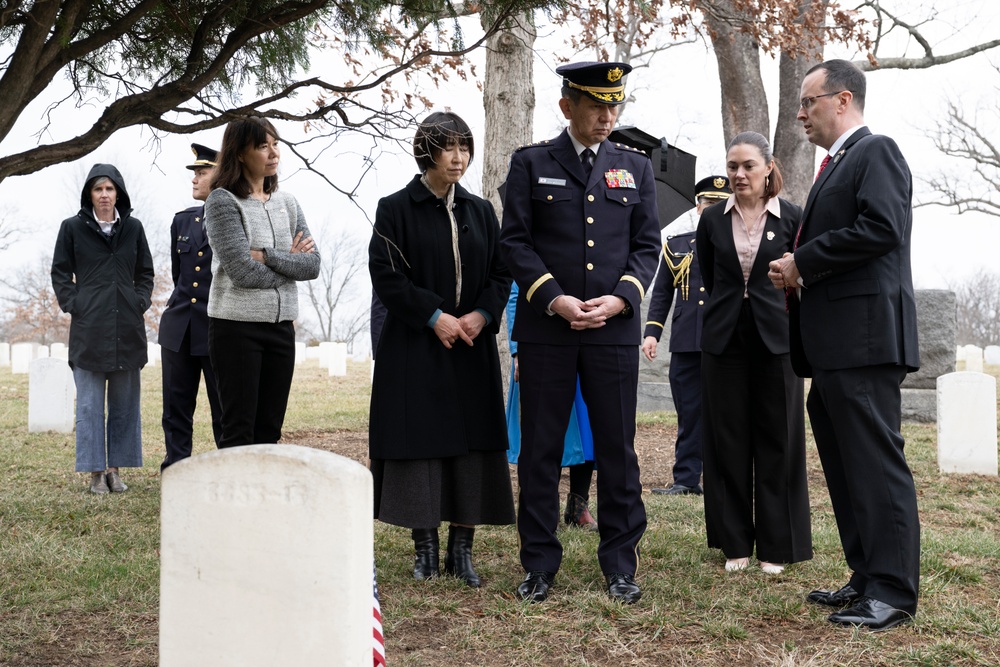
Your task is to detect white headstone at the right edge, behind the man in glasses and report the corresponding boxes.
[937,372,997,475]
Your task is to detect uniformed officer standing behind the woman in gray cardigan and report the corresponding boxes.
[159,144,222,471]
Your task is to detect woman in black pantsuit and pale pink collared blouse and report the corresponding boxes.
[696,132,812,574]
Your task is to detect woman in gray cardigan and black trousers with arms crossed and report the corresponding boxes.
[199,118,320,447]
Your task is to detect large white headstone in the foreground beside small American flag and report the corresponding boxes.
[159,445,374,667]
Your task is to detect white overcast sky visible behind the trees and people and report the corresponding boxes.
[0,0,1000,306]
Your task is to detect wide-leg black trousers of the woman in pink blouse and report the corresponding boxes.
[701,303,812,563]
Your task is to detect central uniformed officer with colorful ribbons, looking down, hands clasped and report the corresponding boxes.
[500,63,660,603]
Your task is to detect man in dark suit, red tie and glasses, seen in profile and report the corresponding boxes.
[769,60,920,630]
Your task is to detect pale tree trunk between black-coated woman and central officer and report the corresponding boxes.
[476,13,535,392]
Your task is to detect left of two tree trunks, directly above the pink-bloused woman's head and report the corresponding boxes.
[705,0,771,146]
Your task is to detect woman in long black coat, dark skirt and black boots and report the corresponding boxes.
[368,113,514,587]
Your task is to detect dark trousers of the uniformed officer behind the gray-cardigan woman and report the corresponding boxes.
[160,328,222,470]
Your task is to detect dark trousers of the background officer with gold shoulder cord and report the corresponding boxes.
[670,352,701,487]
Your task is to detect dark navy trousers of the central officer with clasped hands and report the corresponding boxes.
[517,342,646,574]
